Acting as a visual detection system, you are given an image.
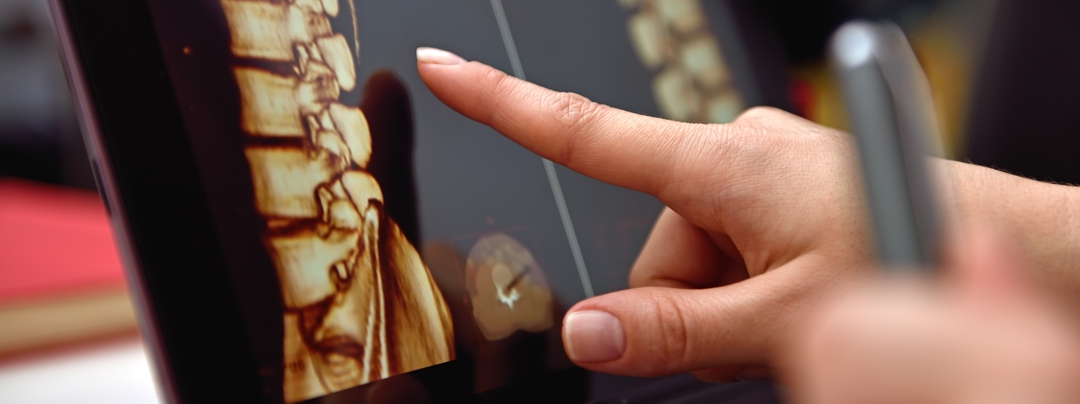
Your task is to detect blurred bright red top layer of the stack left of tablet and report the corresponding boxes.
[0,178,124,305]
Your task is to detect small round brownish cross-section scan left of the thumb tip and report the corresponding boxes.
[465,233,554,341]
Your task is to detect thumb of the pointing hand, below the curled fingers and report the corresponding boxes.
[563,261,820,377]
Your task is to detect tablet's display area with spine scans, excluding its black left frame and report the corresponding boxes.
[139,0,746,403]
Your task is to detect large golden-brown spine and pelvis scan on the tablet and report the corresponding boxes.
[221,0,454,402]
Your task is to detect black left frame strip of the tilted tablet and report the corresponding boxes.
[50,0,272,402]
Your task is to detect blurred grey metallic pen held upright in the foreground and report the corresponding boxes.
[829,21,942,271]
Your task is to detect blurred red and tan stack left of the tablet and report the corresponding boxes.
[0,178,136,355]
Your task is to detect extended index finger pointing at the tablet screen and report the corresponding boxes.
[417,48,718,194]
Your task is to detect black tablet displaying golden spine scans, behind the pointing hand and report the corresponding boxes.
[52,0,784,403]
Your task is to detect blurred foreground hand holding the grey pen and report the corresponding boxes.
[785,226,1080,404]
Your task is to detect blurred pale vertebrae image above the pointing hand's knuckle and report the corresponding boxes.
[619,0,744,123]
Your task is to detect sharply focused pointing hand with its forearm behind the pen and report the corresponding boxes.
[417,49,1080,381]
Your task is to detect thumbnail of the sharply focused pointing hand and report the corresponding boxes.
[563,310,626,362]
